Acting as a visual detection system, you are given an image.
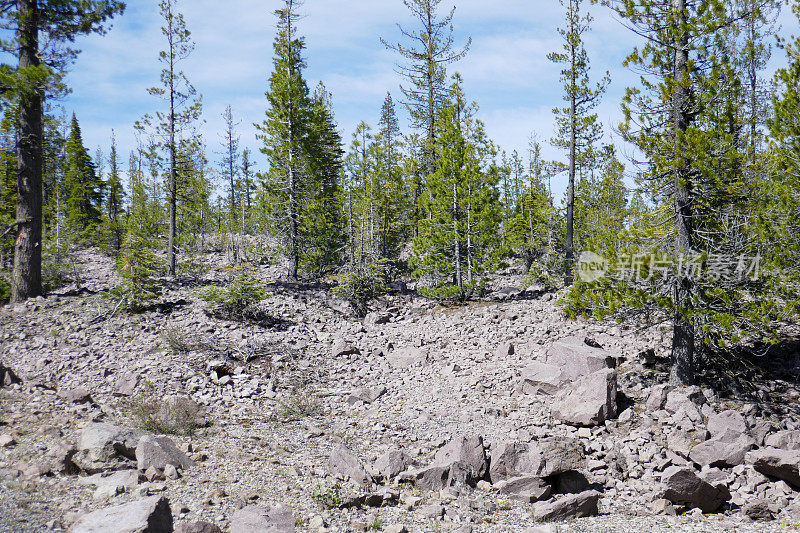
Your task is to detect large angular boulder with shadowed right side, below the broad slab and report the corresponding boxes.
[551,368,617,426]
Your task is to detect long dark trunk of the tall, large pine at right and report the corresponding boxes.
[669,0,694,385]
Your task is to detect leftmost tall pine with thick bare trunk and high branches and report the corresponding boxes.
[0,0,125,302]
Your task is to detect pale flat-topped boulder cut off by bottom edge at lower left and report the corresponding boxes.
[69,496,172,533]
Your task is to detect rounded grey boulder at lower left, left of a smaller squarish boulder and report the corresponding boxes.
[72,422,145,474]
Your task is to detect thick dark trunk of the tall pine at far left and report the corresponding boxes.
[11,0,43,303]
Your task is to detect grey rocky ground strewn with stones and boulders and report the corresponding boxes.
[0,247,800,533]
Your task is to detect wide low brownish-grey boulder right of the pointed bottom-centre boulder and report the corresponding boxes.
[489,437,584,483]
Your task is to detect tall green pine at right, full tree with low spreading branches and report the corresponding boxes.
[594,0,796,385]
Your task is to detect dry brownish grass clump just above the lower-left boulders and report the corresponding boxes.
[129,393,201,436]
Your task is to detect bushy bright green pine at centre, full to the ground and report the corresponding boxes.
[411,76,503,301]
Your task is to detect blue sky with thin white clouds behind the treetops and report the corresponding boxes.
[60,0,793,192]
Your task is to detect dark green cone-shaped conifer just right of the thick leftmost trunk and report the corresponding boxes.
[64,113,103,240]
